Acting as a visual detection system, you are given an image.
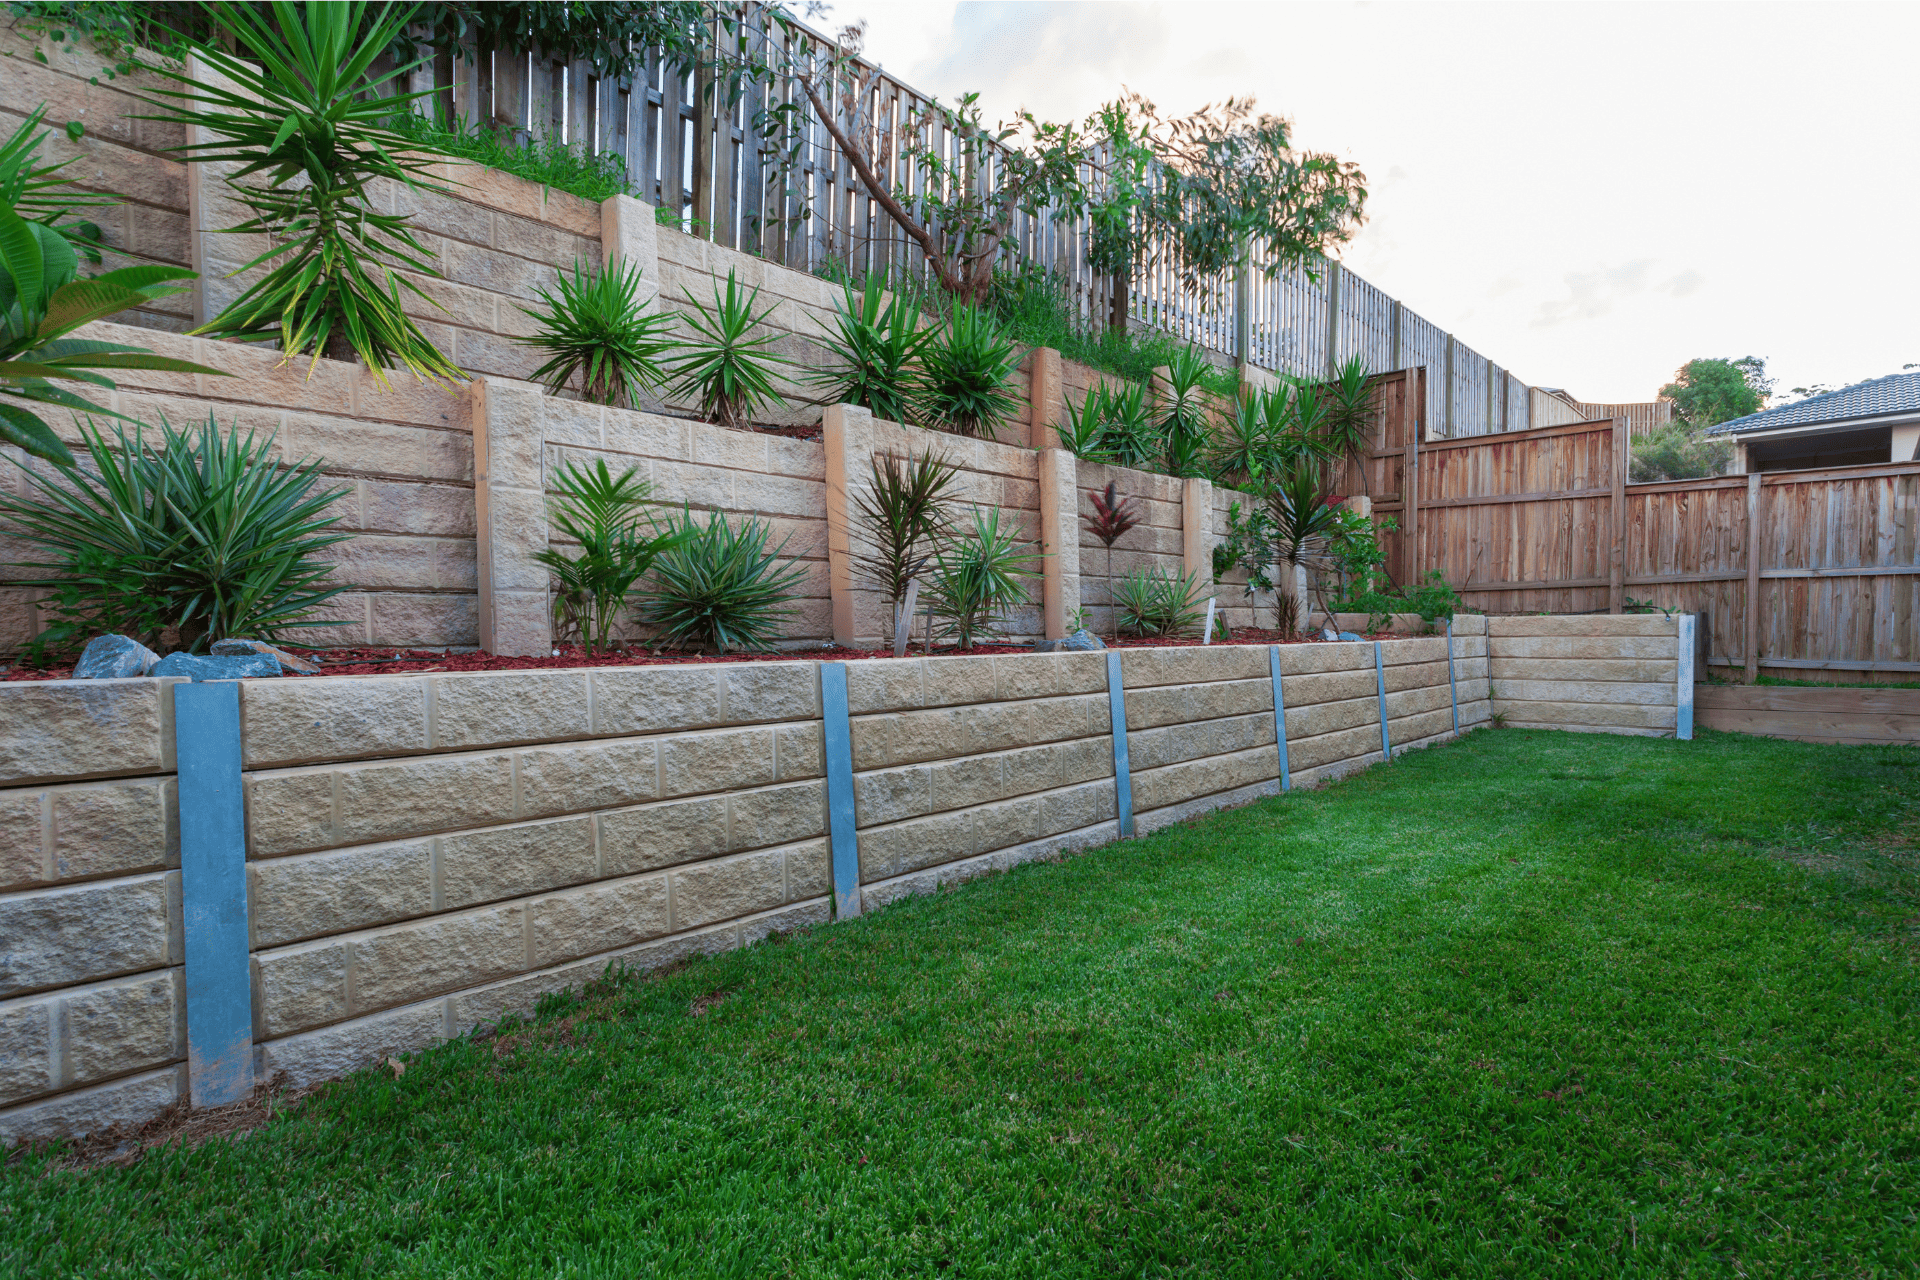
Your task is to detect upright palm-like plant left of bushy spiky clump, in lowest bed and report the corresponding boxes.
[534,459,693,652]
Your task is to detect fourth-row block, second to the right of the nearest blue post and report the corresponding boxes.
[349,902,530,1013]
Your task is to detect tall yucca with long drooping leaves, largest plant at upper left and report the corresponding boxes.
[142,0,467,386]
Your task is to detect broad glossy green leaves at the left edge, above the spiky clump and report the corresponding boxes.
[0,192,219,466]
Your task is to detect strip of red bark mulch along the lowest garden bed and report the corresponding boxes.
[0,628,1392,681]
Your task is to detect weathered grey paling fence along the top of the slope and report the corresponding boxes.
[413,6,1605,438]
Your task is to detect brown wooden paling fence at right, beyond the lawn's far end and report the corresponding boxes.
[1350,397,1920,681]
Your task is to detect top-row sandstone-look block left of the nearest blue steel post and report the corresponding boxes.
[0,679,173,787]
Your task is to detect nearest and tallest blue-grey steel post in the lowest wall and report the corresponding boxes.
[173,679,253,1107]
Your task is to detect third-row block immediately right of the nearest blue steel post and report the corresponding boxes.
[248,841,434,946]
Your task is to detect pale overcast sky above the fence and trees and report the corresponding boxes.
[840,0,1920,401]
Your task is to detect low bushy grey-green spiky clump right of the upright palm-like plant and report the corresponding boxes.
[637,509,806,652]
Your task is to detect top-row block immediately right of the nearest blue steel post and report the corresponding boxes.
[240,676,428,770]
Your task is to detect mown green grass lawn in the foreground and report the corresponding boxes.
[0,729,1920,1278]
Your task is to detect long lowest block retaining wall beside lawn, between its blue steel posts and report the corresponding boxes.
[0,618,1536,1142]
